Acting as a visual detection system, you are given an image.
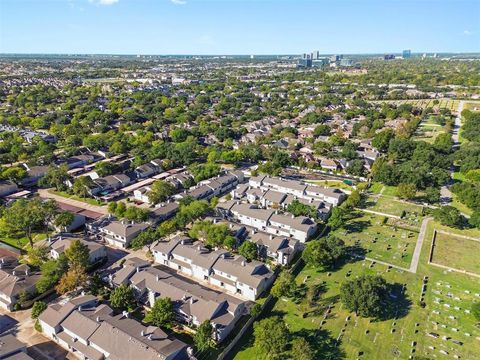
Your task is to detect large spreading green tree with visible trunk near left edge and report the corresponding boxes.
[3,199,46,247]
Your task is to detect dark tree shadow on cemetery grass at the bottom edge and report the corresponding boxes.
[292,329,346,360]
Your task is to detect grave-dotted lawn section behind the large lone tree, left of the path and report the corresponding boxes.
[333,212,418,268]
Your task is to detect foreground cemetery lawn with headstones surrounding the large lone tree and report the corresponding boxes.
[235,217,480,360]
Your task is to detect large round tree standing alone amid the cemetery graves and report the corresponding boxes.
[340,275,387,317]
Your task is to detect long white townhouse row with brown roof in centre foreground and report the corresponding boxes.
[152,236,274,300]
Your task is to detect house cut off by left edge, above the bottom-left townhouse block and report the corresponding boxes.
[0,256,41,311]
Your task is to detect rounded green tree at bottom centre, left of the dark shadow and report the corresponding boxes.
[253,317,290,359]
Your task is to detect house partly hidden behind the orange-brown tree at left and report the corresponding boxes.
[37,235,107,264]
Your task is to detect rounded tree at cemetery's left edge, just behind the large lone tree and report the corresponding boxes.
[302,236,345,269]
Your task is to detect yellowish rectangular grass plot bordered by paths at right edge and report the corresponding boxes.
[432,233,480,275]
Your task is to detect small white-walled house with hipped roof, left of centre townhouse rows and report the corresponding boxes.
[100,220,149,249]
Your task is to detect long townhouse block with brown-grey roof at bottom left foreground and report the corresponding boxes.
[39,296,188,360]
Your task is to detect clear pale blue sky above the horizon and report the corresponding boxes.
[0,0,480,54]
